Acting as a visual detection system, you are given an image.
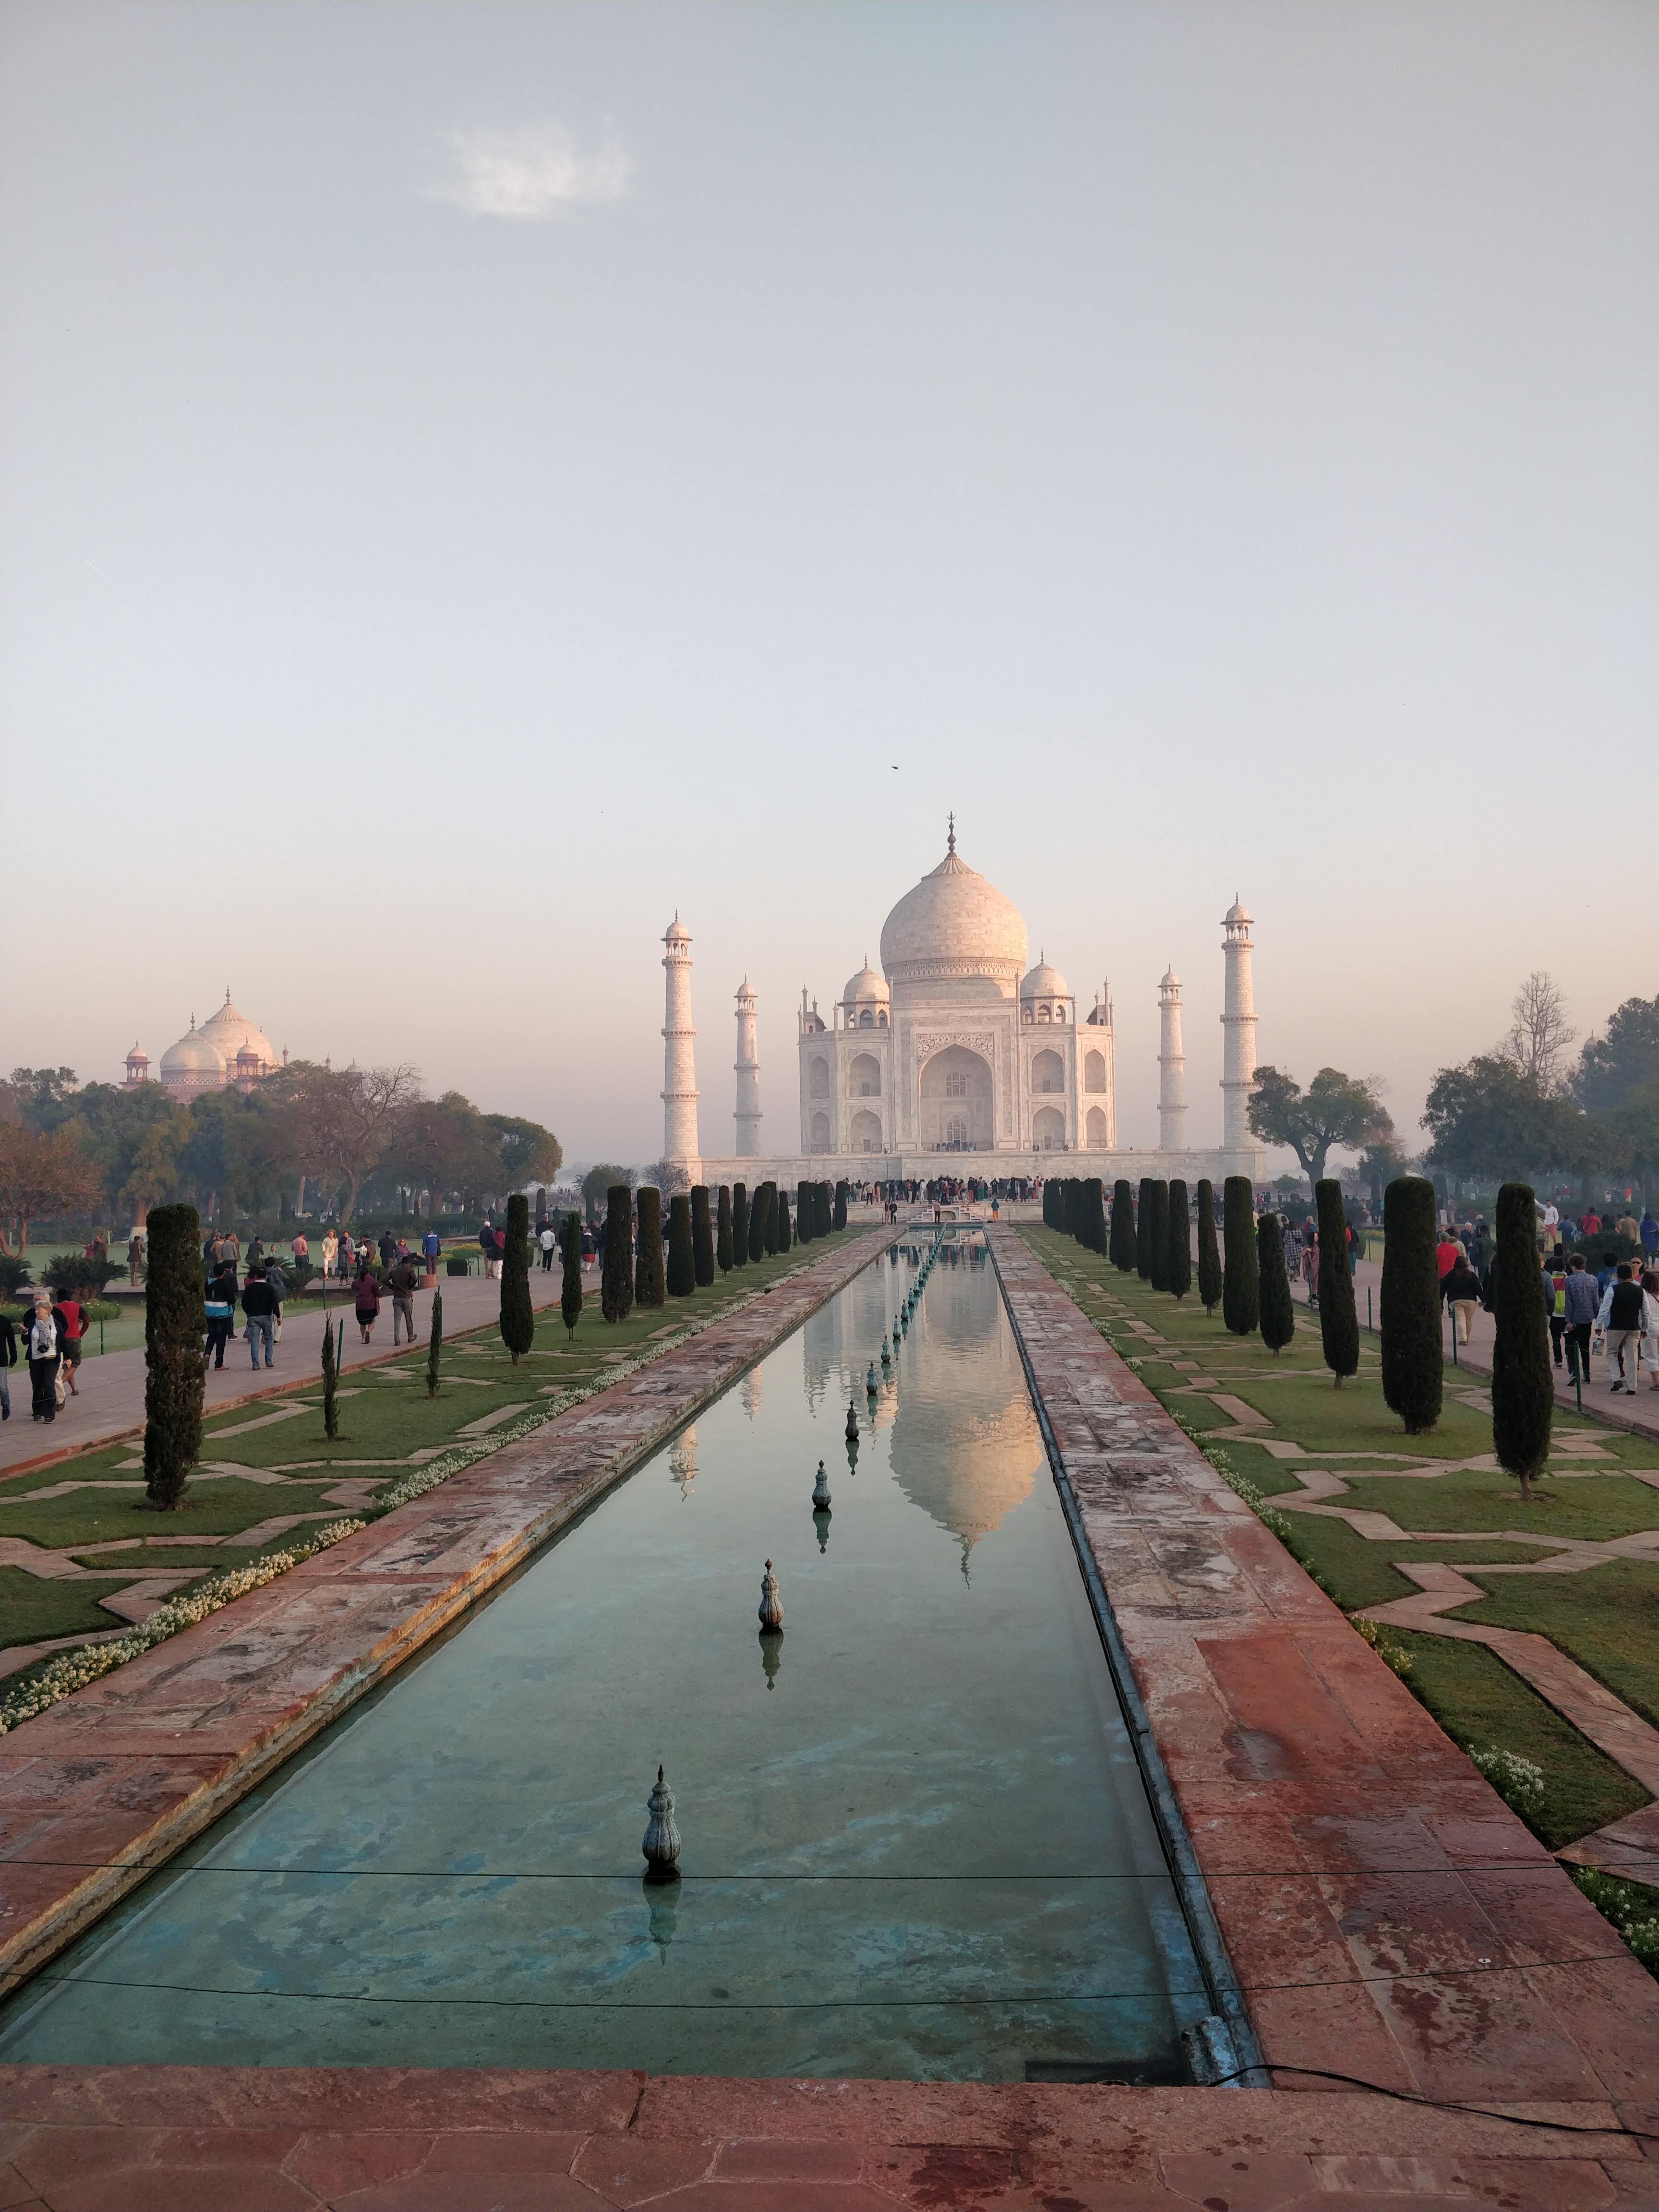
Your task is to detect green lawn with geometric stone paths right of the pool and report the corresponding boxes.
[1022,1227,1659,1847]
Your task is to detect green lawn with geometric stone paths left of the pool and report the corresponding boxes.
[0,1230,861,1644]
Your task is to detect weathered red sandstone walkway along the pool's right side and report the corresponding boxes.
[991,1230,1659,2117]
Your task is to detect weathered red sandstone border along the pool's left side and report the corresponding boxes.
[0,1223,898,1997]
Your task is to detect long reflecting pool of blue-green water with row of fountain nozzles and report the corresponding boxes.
[0,1243,1208,2080]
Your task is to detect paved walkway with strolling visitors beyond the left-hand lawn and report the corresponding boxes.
[0,1267,600,1478]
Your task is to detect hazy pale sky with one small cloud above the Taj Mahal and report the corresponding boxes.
[0,0,1659,1159]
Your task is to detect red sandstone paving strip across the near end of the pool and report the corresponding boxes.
[0,2066,1659,2212]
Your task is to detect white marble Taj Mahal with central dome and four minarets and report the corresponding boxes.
[661,816,1263,1183]
